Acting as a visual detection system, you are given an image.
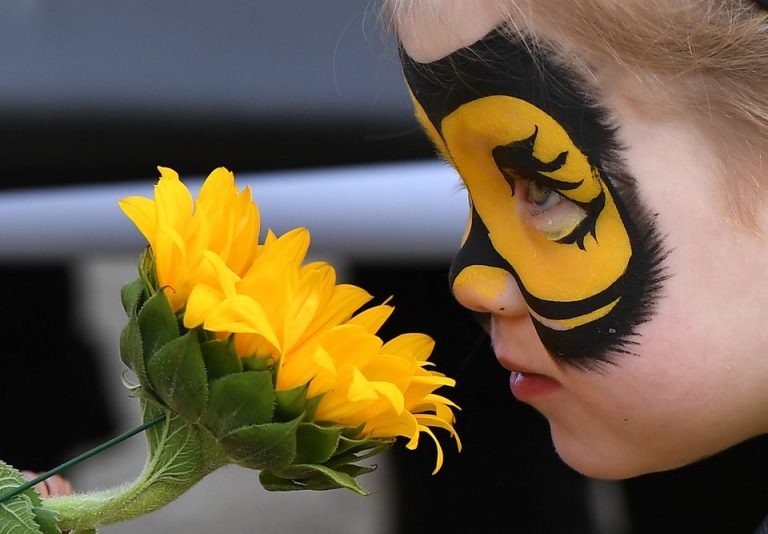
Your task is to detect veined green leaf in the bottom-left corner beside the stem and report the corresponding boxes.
[0,461,60,534]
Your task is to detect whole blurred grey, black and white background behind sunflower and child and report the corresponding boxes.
[0,0,768,534]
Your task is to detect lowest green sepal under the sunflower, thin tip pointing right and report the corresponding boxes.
[259,464,370,495]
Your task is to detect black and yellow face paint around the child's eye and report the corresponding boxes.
[401,32,665,368]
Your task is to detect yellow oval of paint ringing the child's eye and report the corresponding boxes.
[441,96,632,310]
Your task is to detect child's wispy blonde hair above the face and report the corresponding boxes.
[384,0,768,227]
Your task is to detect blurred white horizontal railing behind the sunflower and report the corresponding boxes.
[0,162,467,261]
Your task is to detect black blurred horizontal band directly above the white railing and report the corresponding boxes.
[0,116,433,190]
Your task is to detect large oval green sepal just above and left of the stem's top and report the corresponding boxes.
[142,330,208,422]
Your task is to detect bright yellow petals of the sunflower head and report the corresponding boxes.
[120,167,461,472]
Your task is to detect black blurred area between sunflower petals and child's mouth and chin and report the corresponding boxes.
[353,265,592,534]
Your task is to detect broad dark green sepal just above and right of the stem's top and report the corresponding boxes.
[202,371,275,436]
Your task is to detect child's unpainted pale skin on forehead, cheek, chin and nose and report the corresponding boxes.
[398,0,768,478]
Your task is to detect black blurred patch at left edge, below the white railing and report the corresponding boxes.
[0,265,115,471]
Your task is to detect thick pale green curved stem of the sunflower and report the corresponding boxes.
[44,408,227,530]
